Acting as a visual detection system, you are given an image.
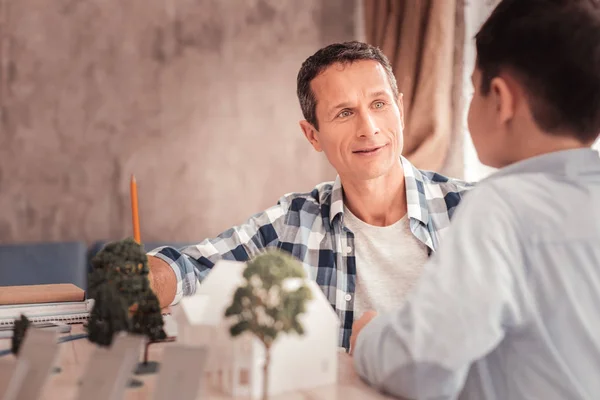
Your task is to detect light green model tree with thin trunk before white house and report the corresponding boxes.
[225,250,311,399]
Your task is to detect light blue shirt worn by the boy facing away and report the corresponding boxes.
[354,149,600,400]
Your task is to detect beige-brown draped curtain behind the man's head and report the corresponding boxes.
[364,0,464,176]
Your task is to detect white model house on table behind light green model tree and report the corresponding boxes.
[173,261,339,399]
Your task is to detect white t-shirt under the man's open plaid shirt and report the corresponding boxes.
[344,206,428,319]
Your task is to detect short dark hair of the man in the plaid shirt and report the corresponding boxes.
[297,41,398,129]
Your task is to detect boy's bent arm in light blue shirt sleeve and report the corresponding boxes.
[354,187,523,399]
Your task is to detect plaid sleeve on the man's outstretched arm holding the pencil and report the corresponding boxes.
[148,199,288,305]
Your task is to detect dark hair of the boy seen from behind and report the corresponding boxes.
[475,0,600,142]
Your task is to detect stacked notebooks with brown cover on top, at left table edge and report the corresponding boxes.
[0,284,94,327]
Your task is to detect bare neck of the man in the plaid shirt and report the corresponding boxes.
[341,160,407,226]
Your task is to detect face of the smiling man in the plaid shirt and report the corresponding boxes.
[301,60,404,180]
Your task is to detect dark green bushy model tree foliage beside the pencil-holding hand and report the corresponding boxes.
[87,238,166,346]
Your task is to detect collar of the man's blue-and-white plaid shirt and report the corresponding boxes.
[329,156,429,225]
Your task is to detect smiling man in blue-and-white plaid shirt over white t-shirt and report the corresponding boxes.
[149,42,471,349]
